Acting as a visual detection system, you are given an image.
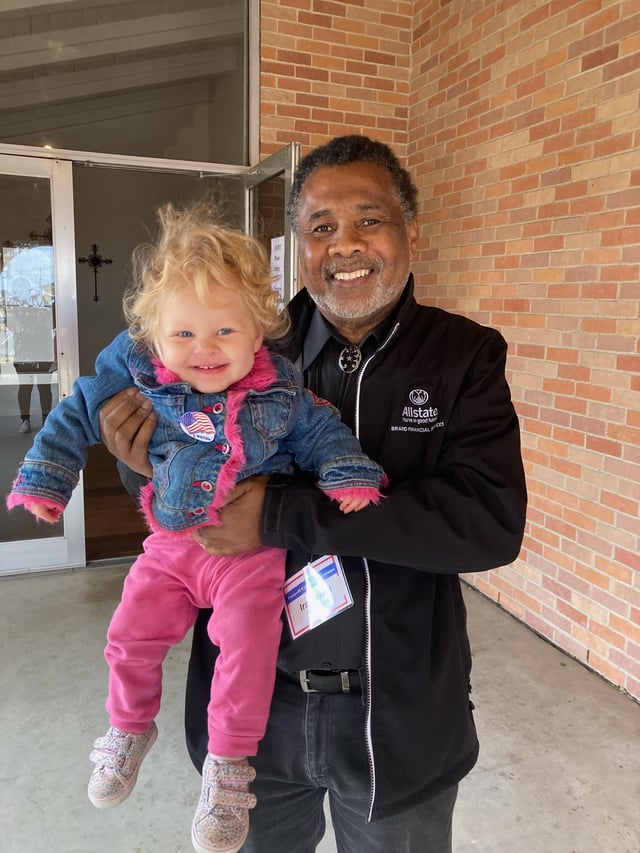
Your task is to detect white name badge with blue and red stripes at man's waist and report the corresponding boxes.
[284,554,353,640]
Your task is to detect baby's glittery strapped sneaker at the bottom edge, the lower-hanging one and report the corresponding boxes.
[191,755,256,853]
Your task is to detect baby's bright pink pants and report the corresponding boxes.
[105,533,285,758]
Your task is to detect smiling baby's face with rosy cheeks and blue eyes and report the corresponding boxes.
[155,282,262,394]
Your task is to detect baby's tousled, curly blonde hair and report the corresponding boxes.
[123,202,290,354]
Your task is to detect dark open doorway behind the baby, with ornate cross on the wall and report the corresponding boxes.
[73,165,244,562]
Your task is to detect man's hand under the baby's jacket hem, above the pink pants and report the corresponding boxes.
[192,475,269,557]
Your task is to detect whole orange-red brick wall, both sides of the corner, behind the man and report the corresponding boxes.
[261,0,640,698]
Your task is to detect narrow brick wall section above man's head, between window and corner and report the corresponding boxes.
[260,0,414,158]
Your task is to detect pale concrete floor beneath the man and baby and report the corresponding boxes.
[0,566,640,853]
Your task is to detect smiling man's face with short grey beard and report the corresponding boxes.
[298,161,418,343]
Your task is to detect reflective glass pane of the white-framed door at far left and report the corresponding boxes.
[0,175,62,542]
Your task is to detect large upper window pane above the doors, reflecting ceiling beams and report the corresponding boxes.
[0,0,248,165]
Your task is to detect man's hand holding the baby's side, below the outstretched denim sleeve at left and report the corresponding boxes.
[100,388,158,477]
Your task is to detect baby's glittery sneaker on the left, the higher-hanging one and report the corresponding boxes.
[87,723,158,809]
